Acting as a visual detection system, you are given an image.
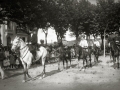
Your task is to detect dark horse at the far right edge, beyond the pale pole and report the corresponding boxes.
[109,39,119,68]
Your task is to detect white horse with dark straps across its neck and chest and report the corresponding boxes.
[11,36,47,82]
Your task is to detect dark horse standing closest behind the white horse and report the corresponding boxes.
[56,46,71,70]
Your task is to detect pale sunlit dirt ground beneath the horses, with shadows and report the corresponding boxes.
[0,56,120,90]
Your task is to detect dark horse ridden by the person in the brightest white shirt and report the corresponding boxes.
[75,45,92,68]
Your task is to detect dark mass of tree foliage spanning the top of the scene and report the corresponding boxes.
[0,0,120,42]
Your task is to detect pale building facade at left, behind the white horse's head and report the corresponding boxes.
[0,21,28,46]
